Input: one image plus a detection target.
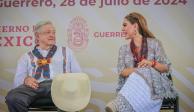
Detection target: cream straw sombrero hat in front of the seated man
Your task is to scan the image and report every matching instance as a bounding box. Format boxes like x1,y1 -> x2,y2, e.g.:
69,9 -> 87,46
51,73 -> 91,111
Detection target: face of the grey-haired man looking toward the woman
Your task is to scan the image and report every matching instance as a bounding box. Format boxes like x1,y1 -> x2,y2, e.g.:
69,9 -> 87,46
36,24 -> 56,46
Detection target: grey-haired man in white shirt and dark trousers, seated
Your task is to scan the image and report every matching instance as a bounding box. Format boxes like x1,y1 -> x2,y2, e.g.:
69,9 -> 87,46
6,21 -> 81,112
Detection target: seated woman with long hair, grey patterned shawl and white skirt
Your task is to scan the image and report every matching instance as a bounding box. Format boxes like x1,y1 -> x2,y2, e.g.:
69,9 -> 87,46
105,12 -> 176,112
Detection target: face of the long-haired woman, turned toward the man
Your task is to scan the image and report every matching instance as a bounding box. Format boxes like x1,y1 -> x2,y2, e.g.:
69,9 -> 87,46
122,19 -> 137,39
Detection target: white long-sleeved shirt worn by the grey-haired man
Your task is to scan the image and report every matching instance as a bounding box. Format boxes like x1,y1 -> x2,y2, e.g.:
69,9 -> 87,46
13,47 -> 81,88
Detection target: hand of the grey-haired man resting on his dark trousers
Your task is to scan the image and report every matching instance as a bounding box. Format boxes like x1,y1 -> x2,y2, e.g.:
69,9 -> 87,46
24,76 -> 39,89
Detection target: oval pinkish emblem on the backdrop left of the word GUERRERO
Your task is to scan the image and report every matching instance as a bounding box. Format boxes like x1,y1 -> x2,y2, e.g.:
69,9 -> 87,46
67,16 -> 89,50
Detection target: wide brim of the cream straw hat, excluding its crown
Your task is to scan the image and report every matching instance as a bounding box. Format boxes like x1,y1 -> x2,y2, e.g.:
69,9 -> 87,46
51,73 -> 91,111
